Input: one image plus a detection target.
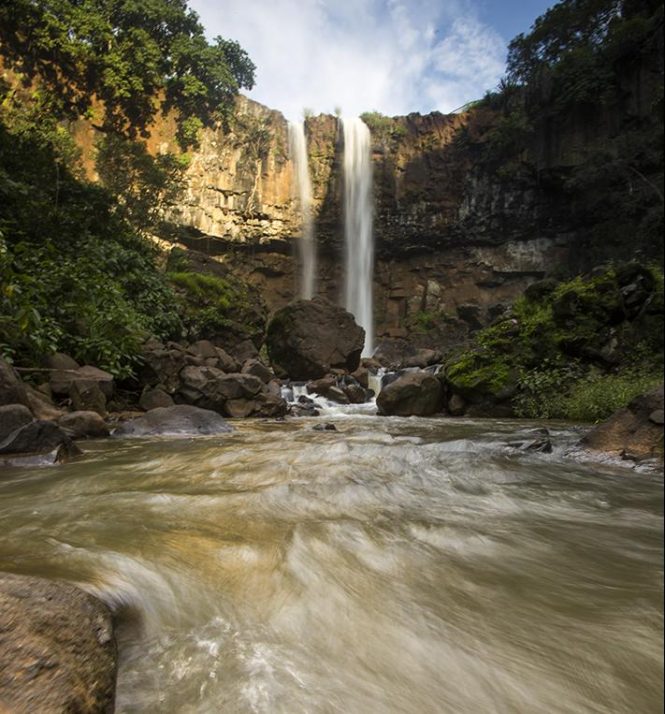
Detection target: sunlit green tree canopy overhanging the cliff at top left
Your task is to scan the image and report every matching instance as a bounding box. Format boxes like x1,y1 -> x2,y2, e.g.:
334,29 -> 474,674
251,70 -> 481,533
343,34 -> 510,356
0,0 -> 255,143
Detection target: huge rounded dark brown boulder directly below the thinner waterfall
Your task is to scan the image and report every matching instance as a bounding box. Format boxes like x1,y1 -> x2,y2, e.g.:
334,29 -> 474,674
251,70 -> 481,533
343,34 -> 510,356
267,297 -> 365,380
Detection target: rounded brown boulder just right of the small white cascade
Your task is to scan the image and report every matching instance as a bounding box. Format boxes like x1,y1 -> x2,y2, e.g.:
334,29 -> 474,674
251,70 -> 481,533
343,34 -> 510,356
376,372 -> 443,416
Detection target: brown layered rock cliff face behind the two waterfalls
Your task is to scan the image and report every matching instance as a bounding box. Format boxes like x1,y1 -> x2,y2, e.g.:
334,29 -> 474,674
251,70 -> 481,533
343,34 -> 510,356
162,99 -> 569,344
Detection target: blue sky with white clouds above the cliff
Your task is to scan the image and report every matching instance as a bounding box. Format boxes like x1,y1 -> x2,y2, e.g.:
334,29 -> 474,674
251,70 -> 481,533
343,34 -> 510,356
189,0 -> 554,121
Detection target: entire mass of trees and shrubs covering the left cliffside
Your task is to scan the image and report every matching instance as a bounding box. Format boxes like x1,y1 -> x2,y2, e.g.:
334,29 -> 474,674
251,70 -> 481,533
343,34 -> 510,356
0,0 -> 254,376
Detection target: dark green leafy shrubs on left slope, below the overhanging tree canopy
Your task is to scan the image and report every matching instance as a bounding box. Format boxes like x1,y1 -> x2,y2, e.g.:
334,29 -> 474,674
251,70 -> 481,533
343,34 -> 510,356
0,80 -> 182,376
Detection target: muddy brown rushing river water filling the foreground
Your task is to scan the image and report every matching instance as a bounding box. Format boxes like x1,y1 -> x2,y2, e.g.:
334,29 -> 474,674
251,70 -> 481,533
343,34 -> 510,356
0,414 -> 663,714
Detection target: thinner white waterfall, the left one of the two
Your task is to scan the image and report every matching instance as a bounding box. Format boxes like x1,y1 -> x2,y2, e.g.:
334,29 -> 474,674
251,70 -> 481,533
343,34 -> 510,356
289,122 -> 316,300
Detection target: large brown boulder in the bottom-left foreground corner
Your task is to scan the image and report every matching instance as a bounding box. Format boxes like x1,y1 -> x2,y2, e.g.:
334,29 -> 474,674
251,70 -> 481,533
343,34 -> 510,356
0,573 -> 117,714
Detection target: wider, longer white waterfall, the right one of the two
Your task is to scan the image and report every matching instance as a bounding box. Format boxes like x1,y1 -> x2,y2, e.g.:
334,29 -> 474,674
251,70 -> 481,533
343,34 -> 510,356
342,117 -> 374,357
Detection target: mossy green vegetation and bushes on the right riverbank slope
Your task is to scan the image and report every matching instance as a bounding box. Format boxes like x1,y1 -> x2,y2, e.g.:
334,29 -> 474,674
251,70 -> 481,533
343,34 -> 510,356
446,263 -> 663,421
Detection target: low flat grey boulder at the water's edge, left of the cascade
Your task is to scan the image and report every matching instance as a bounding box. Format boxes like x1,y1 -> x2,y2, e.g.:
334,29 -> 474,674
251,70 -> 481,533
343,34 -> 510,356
113,404 -> 232,437
